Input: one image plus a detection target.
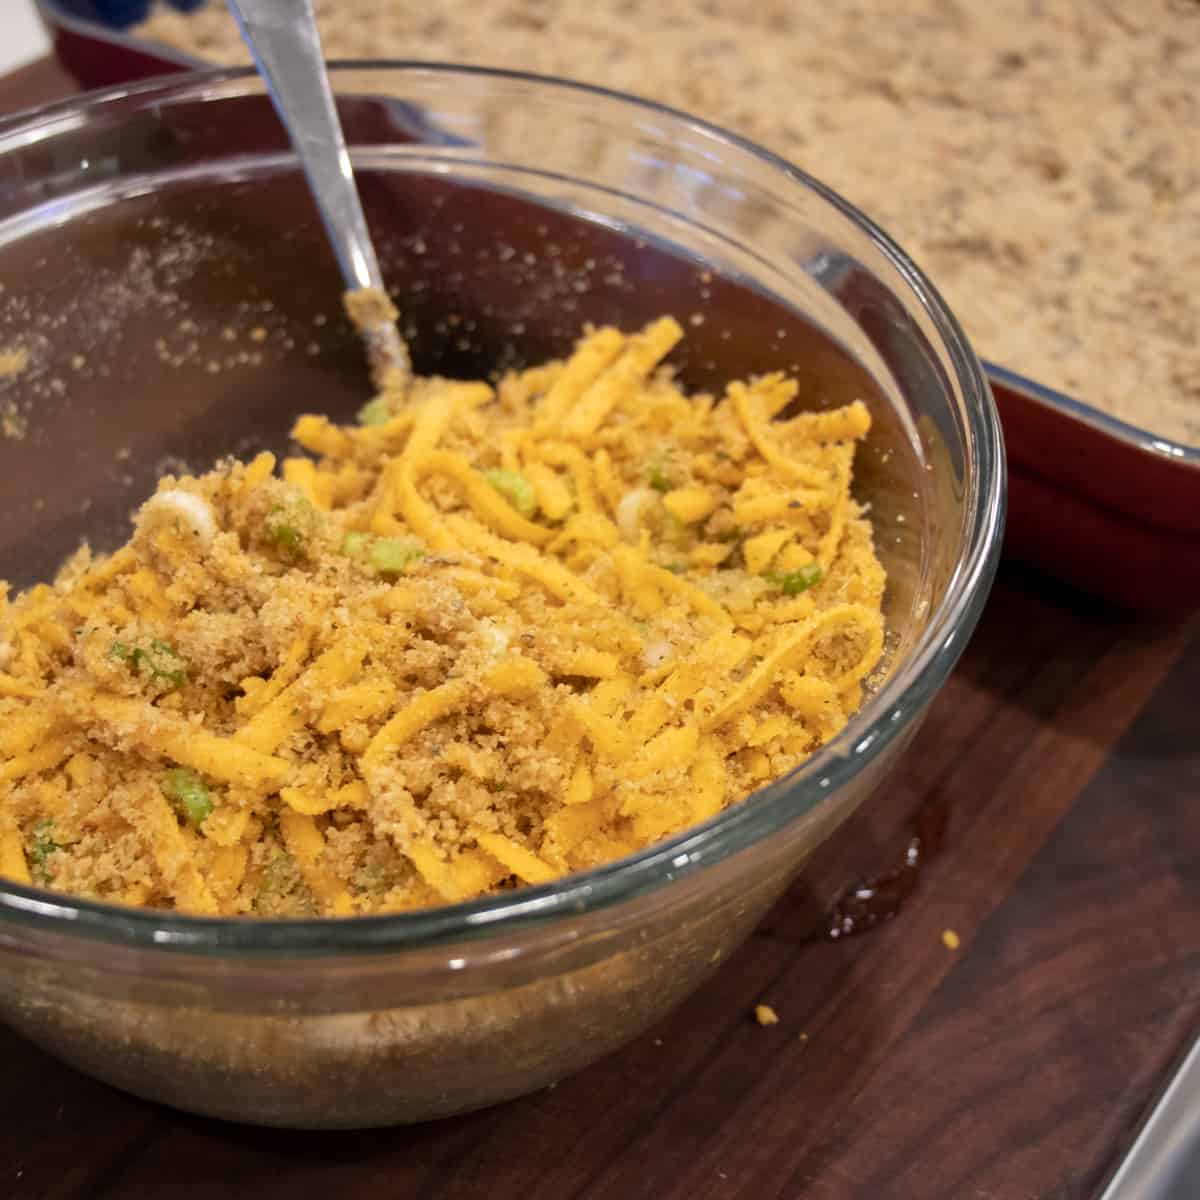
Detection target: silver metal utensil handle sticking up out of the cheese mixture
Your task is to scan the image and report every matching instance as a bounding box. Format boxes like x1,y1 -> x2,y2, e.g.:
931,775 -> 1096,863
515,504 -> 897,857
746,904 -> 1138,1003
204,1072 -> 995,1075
229,0 -> 412,389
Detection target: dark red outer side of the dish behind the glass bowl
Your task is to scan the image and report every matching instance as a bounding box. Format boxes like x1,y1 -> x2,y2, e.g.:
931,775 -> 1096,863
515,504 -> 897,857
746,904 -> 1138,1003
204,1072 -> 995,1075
25,0 -> 1200,611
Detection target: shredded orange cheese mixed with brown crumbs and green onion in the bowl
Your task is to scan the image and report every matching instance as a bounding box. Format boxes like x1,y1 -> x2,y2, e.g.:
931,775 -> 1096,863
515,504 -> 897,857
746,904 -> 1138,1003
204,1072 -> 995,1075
0,318 -> 884,907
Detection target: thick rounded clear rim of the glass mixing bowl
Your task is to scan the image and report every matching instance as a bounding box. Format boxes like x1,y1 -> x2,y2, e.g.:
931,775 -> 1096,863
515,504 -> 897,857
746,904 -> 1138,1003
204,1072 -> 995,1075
0,59 -> 1007,958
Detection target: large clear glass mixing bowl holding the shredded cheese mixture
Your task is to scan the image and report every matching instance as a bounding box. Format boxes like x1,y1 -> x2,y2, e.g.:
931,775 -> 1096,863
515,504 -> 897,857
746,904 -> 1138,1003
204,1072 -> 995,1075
0,64 -> 1004,1128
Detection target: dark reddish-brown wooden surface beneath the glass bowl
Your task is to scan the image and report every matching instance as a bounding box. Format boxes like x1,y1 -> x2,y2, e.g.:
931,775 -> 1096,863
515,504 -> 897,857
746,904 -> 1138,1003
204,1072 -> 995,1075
0,64 -> 1200,1200
